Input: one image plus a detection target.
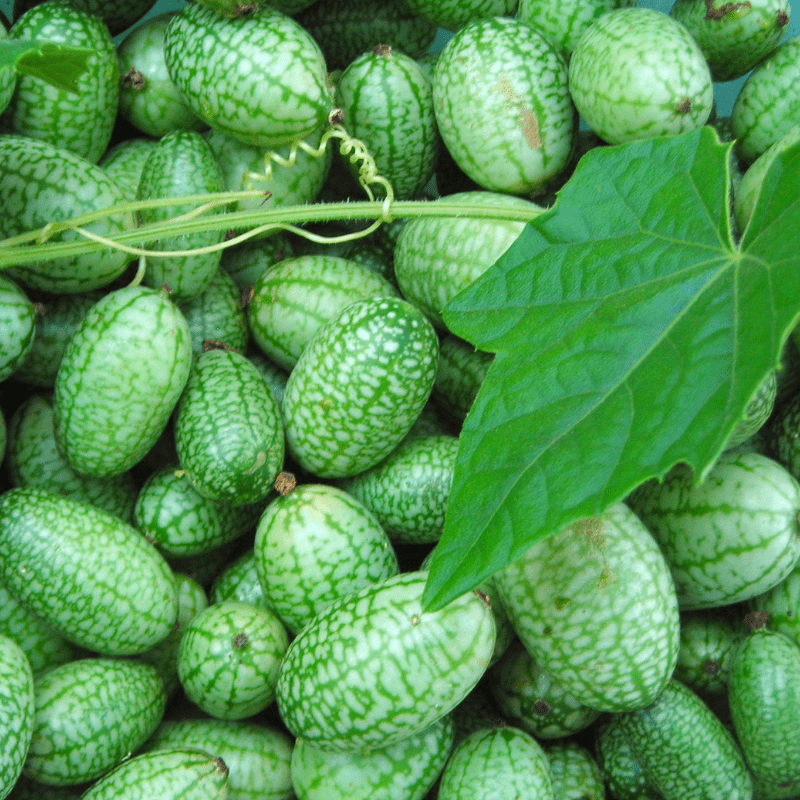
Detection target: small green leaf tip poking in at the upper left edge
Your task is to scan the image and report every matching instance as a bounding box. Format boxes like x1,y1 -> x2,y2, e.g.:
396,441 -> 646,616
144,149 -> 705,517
0,39 -> 94,94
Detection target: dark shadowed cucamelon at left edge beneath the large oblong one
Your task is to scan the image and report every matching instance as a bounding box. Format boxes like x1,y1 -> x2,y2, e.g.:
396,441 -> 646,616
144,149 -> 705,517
0,583 -> 82,675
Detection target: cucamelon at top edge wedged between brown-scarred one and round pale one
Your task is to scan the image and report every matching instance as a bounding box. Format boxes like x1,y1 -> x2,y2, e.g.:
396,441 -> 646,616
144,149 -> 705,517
517,0 -> 636,62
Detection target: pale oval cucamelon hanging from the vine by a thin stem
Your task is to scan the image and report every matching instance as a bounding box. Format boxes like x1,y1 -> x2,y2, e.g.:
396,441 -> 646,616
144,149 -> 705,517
53,286 -> 192,477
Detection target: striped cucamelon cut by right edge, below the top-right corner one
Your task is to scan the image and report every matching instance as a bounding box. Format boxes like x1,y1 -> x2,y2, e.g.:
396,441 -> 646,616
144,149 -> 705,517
731,36 -> 800,162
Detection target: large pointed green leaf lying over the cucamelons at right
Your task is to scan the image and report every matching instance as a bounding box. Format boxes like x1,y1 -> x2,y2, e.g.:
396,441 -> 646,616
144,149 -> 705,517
424,128 -> 800,609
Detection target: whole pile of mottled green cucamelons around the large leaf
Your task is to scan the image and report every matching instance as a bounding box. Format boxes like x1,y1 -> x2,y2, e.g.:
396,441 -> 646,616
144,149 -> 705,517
0,0 -> 800,800
